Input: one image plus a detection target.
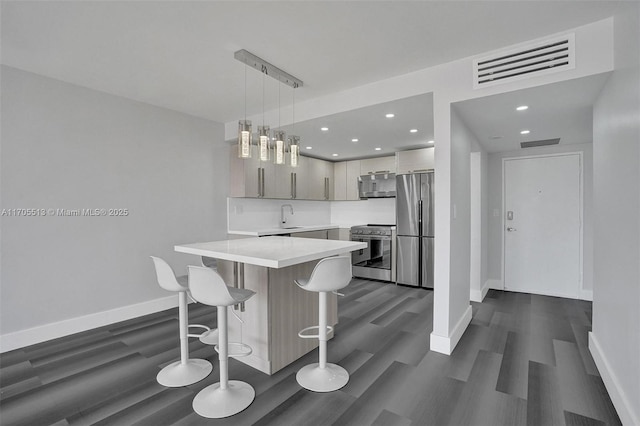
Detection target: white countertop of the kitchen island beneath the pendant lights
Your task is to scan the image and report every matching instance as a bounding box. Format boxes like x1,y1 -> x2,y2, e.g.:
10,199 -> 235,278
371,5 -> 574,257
174,235 -> 367,268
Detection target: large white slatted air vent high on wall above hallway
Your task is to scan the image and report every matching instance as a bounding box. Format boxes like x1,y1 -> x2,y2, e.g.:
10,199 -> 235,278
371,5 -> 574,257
473,34 -> 575,89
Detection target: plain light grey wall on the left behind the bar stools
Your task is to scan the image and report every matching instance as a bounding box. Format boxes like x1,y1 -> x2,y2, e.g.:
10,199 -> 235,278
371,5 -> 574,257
0,67 -> 228,351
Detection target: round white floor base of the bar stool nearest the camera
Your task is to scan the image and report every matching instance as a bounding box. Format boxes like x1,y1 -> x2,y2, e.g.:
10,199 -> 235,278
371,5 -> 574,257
193,380 -> 256,419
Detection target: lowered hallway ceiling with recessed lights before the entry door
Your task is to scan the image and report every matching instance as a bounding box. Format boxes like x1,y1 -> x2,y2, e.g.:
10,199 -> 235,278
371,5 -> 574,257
454,73 -> 609,153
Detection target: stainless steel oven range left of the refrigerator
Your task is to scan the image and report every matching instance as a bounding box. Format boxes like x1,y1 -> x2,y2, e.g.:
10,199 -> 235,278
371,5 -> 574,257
350,224 -> 395,281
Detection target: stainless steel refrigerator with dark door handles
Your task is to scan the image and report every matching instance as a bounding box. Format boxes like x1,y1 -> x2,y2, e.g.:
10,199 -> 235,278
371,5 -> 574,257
396,172 -> 434,288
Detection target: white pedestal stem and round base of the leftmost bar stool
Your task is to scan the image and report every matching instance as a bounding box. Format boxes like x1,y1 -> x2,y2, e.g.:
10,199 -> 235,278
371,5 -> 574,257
156,291 -> 213,388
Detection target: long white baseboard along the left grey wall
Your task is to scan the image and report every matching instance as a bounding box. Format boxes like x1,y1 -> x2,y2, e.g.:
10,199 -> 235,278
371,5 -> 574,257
0,295 -> 178,353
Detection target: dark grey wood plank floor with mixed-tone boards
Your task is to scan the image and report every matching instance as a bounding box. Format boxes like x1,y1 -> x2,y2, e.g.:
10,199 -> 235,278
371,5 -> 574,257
0,280 -> 620,426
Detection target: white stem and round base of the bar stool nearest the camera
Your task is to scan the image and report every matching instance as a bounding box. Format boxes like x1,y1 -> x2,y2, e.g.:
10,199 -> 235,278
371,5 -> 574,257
193,306 -> 256,419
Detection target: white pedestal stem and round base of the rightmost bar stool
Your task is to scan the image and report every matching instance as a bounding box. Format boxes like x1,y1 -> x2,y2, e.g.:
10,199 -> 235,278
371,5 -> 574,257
296,291 -> 349,392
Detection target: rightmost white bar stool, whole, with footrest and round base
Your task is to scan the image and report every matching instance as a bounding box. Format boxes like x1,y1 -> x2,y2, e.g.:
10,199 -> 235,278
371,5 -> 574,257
295,256 -> 352,392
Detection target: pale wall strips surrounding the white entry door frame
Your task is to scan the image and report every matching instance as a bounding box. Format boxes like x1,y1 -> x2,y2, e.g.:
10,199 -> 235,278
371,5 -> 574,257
487,143 -> 593,300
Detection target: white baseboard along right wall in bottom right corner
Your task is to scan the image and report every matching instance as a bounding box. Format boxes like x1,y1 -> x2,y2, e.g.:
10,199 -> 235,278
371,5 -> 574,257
589,332 -> 640,425
